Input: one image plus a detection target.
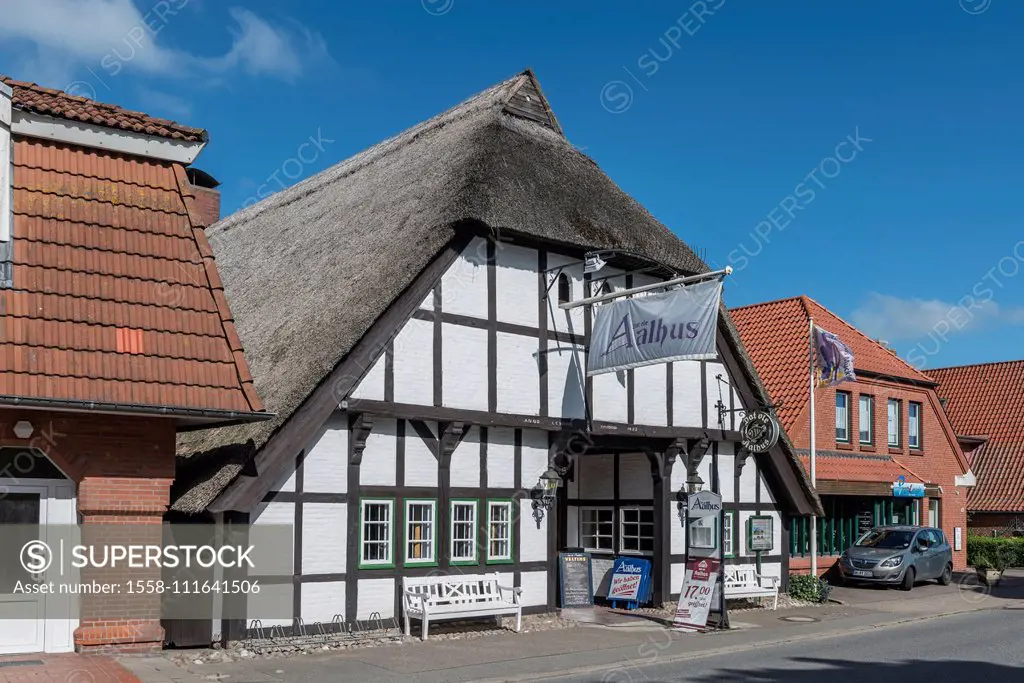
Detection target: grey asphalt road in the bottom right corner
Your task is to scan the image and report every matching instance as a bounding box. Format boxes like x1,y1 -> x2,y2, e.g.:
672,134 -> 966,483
544,609 -> 1024,683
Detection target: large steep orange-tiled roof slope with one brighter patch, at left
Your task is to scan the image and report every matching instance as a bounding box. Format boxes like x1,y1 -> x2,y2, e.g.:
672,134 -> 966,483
0,137 -> 262,413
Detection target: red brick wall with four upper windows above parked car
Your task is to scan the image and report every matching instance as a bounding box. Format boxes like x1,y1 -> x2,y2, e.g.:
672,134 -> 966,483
790,378 -> 968,570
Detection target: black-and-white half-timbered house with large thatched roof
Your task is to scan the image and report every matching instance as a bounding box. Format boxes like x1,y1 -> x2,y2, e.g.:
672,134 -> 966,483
173,72 -> 818,637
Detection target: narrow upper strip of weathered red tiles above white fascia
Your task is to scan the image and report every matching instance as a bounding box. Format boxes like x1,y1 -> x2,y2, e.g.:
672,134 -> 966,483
0,75 -> 207,142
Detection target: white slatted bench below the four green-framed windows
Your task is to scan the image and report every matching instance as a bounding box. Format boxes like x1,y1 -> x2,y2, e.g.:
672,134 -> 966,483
401,572 -> 522,640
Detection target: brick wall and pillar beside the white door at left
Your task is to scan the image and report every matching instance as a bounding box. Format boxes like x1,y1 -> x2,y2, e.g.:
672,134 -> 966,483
0,410 -> 174,650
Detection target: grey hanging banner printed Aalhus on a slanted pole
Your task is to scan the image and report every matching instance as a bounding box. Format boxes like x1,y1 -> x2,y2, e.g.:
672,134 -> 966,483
587,280 -> 722,375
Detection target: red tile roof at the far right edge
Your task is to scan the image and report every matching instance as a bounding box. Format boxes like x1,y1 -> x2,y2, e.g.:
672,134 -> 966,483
928,360 -> 1024,512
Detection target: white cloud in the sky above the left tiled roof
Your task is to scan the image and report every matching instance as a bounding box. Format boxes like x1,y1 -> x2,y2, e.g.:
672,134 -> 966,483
0,0 -> 330,87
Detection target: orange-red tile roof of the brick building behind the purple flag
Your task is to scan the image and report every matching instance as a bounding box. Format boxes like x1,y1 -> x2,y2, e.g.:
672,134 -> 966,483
729,296 -> 933,431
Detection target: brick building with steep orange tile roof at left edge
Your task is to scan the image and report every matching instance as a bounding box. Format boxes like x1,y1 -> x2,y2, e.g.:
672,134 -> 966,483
0,77 -> 268,654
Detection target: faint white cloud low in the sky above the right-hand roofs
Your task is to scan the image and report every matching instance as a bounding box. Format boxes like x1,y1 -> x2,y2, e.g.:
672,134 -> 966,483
850,292 -> 1024,342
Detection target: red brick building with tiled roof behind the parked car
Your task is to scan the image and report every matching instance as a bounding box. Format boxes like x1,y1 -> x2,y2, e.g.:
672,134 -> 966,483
732,296 -> 974,572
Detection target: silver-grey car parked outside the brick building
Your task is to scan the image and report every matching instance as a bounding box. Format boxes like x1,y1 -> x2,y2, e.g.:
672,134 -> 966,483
839,526 -> 953,591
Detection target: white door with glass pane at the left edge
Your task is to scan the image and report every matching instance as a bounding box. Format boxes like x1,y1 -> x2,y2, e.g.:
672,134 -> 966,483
0,484 -> 49,654
